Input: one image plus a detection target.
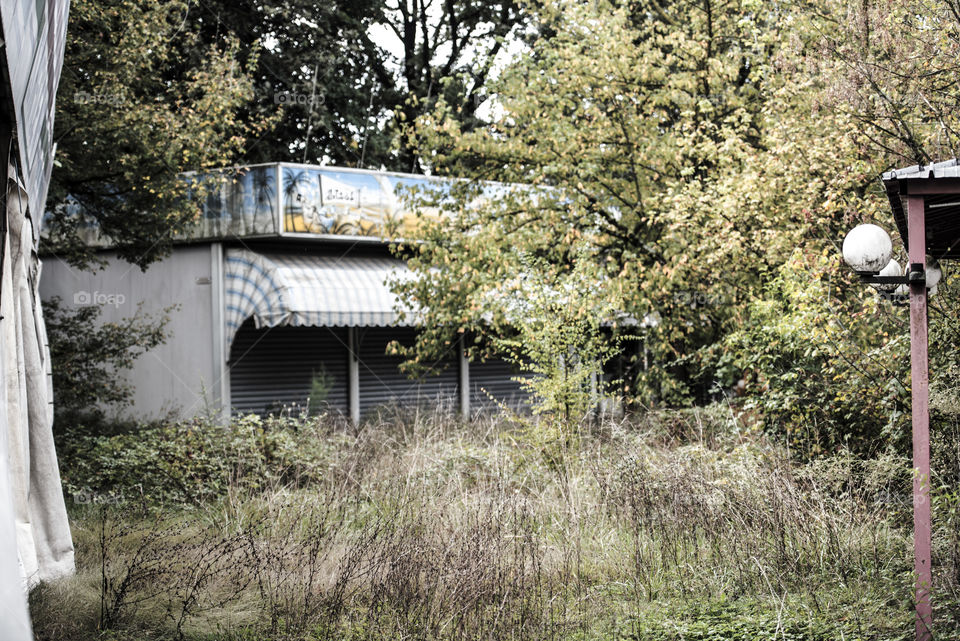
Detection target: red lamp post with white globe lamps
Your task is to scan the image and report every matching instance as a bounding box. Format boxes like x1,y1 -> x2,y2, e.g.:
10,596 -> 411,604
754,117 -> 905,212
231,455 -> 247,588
843,216 -> 941,641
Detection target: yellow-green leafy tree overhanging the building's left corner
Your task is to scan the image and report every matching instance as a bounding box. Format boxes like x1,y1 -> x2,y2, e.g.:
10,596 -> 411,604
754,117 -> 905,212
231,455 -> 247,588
43,0 -> 263,267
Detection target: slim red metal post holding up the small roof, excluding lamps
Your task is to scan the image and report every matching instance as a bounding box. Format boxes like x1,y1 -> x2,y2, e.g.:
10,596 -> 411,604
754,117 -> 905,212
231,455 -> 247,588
907,196 -> 933,641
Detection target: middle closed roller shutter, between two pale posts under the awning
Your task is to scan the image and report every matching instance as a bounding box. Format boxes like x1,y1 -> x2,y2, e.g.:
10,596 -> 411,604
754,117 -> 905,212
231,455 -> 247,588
357,327 -> 457,415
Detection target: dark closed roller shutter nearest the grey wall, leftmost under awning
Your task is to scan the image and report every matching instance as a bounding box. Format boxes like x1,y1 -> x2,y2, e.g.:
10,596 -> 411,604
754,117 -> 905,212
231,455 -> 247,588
230,320 -> 347,414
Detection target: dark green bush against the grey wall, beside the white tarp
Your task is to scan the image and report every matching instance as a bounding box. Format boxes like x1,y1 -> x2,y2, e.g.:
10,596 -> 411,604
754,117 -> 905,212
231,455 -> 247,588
43,297 -> 170,432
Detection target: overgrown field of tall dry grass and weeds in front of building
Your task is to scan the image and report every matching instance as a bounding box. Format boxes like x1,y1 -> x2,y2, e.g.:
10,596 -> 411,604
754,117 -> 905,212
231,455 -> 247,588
31,408 -> 960,641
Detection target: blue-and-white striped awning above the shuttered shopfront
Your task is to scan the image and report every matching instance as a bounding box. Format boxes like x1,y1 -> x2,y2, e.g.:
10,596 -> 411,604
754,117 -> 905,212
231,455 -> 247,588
224,249 -> 411,343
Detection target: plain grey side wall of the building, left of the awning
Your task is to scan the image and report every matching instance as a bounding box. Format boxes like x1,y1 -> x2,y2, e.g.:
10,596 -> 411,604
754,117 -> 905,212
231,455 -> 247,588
40,244 -> 223,418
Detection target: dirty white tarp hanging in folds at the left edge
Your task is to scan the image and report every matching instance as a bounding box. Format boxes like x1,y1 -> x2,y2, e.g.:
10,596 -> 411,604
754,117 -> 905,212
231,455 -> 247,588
0,167 -> 74,640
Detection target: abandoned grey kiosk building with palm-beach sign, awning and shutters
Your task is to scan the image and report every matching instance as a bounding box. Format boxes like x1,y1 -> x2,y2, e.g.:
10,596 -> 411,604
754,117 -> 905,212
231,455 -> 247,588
40,163 -> 526,421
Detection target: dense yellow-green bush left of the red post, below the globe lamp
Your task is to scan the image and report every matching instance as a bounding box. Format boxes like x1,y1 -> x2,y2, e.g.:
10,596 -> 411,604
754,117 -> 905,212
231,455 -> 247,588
707,250 -> 910,456
